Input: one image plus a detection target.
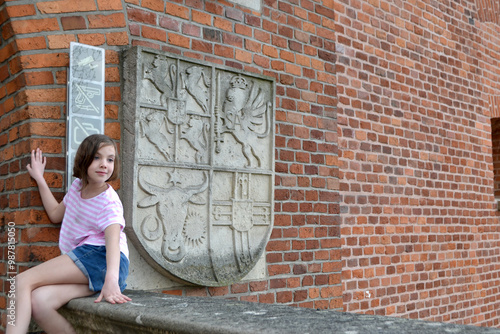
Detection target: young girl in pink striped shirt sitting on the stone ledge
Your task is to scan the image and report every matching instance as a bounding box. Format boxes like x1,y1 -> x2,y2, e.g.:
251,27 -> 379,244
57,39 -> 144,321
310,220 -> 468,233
7,135 -> 130,334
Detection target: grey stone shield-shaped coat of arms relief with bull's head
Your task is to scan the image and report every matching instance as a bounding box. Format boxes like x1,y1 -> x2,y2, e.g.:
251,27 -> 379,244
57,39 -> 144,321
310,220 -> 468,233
121,47 -> 276,286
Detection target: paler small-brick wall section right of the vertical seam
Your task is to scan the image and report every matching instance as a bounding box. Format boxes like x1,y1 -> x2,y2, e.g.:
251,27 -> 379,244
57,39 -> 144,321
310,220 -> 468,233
335,0 -> 500,327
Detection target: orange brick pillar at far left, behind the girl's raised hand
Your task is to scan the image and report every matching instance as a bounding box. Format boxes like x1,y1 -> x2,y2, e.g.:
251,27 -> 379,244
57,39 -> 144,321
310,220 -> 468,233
0,1 -> 128,328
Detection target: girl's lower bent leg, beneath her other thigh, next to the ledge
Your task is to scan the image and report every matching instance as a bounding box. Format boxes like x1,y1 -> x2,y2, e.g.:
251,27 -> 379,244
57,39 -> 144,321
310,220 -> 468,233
31,284 -> 95,334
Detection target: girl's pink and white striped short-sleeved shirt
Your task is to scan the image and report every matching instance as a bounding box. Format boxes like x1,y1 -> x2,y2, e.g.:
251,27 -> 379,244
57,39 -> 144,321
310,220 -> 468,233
59,179 -> 128,258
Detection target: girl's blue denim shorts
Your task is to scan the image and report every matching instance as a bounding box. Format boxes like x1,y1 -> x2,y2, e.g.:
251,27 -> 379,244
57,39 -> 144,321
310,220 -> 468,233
67,245 -> 129,292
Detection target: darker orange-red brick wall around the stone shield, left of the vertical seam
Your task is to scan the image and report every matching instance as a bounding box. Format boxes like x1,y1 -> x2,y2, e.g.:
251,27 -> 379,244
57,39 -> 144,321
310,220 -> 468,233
0,0 -> 342,332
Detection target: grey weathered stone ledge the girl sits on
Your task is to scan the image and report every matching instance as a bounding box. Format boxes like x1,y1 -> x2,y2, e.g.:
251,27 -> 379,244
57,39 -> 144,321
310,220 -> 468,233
60,291 -> 500,334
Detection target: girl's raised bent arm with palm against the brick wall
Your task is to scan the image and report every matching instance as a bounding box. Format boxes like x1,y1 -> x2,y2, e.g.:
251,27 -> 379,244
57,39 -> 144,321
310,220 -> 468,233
26,148 -> 66,223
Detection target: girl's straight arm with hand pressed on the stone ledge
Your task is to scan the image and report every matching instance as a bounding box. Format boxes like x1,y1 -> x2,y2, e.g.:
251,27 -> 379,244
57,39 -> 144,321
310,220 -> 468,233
95,224 -> 131,304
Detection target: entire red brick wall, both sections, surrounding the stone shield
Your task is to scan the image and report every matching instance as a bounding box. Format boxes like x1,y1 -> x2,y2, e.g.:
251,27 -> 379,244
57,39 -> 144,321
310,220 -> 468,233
0,0 -> 500,327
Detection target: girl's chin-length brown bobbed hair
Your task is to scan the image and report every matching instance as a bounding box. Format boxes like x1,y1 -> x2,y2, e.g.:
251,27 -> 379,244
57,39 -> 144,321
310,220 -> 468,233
73,134 -> 120,189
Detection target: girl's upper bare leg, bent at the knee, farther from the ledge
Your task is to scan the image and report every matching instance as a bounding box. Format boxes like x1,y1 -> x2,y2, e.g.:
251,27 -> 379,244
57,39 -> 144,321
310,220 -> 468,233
7,255 -> 88,334
